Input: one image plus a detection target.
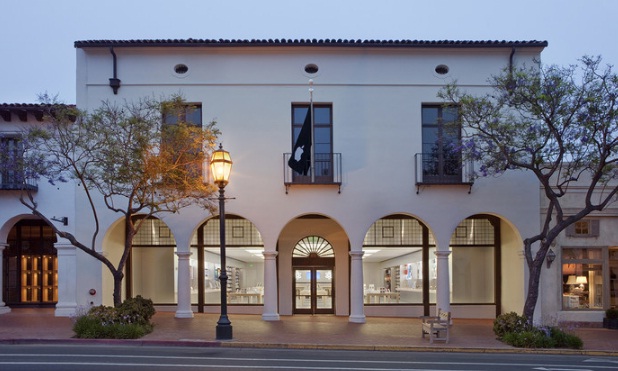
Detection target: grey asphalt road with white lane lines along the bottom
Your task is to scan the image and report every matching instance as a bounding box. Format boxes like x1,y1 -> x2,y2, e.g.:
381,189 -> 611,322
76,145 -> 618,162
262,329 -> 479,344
0,344 -> 618,371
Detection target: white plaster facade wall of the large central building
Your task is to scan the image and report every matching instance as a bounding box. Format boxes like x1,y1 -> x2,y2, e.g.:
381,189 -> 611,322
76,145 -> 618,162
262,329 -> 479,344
72,42 -> 540,313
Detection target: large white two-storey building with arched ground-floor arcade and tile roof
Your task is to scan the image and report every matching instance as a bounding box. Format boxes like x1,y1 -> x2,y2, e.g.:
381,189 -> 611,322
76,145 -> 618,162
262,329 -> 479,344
0,39 -> 558,322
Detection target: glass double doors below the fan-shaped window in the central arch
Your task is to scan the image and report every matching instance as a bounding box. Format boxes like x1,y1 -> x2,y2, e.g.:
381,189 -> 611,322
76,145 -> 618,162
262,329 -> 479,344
294,267 -> 335,314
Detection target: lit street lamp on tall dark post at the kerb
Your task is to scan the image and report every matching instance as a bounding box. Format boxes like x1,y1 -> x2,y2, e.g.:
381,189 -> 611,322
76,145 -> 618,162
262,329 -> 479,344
210,144 -> 232,340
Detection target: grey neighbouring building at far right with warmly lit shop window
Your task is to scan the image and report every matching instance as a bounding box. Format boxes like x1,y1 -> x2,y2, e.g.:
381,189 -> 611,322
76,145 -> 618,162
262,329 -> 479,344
539,174 -> 618,324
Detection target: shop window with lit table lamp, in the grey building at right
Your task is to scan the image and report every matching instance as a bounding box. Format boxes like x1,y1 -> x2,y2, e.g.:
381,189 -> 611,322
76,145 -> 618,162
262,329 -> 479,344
562,247 -> 604,310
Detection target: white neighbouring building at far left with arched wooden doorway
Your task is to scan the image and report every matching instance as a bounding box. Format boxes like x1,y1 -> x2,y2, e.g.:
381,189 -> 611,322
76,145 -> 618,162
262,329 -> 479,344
0,104 -> 76,315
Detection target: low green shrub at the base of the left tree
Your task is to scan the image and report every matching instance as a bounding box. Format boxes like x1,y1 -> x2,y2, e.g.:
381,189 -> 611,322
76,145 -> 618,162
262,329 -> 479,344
73,296 -> 155,339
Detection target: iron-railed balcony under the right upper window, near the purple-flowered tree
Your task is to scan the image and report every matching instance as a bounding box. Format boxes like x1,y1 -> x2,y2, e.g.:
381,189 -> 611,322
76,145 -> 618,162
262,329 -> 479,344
414,153 -> 474,194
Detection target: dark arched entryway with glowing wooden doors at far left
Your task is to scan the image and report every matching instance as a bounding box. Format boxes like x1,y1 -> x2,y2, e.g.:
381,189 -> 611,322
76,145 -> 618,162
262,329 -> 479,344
2,220 -> 58,307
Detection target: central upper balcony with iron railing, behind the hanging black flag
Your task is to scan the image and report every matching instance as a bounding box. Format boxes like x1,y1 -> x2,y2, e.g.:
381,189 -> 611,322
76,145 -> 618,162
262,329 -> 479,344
283,153 -> 341,194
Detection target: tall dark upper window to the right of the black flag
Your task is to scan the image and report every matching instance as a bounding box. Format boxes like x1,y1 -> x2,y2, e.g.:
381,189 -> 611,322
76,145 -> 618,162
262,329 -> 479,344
422,105 -> 462,184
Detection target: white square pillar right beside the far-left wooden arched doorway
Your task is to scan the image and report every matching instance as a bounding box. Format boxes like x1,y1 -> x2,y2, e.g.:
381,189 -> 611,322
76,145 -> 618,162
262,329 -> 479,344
54,243 -> 77,317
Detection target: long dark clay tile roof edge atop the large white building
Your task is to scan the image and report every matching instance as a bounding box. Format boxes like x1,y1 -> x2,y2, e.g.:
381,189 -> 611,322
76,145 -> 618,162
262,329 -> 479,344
75,39 -> 548,48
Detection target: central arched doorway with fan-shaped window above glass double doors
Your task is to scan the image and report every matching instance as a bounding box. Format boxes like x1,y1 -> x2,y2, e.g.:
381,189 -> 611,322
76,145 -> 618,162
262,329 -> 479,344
292,236 -> 335,314
